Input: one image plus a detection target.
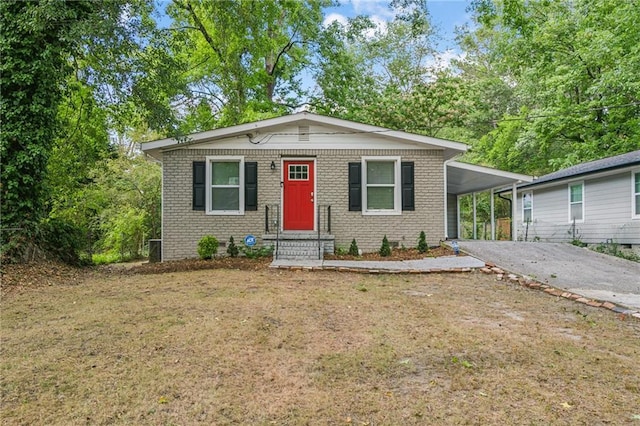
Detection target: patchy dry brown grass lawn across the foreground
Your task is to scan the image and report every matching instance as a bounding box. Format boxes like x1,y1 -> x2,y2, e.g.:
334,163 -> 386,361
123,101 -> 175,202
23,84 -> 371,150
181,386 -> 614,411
0,269 -> 640,425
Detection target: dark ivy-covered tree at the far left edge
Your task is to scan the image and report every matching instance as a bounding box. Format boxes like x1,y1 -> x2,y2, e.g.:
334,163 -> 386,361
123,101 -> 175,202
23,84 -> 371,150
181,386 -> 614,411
0,1 -> 93,257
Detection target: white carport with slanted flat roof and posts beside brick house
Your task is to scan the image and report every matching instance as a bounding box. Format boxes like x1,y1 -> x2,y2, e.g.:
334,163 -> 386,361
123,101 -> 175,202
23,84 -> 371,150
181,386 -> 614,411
444,160 -> 533,241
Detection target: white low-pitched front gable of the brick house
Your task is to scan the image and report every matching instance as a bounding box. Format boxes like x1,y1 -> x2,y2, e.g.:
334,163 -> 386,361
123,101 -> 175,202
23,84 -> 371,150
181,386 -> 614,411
141,112 -> 468,159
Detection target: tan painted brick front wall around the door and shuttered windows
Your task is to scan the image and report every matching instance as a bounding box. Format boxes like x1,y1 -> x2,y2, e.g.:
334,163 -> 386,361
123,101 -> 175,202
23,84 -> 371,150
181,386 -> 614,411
162,149 -> 444,260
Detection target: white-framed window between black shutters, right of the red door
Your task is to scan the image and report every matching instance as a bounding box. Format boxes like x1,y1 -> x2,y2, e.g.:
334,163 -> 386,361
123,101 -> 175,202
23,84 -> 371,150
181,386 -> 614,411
362,157 -> 402,215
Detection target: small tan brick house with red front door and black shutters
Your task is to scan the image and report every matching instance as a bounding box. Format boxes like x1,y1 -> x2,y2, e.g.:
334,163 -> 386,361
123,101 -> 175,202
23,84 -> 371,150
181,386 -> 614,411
142,112 -> 522,260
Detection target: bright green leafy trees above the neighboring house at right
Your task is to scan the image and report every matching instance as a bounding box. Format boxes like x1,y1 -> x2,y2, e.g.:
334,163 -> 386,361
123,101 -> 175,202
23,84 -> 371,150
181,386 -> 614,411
462,0 -> 640,174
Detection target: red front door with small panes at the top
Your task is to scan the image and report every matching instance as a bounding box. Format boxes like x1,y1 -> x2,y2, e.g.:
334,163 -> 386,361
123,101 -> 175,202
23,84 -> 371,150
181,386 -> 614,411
282,160 -> 316,231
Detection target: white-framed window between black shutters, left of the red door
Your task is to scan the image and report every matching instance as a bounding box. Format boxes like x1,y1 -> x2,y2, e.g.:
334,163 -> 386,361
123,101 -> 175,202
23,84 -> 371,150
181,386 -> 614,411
206,156 -> 244,215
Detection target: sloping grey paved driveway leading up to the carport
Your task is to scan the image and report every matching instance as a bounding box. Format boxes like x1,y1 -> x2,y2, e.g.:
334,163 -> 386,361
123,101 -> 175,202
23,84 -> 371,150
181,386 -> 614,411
459,241 -> 640,310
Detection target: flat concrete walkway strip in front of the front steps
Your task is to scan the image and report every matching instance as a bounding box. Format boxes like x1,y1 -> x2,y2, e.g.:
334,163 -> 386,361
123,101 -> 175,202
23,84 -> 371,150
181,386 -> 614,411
271,256 -> 484,272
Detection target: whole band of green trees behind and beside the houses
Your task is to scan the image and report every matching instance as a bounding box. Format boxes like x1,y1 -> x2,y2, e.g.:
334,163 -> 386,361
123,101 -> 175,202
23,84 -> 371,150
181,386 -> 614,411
0,0 -> 640,259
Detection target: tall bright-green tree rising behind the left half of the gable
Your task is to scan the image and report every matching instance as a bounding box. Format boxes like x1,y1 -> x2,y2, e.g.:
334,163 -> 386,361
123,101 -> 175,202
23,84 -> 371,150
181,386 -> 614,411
167,0 -> 331,130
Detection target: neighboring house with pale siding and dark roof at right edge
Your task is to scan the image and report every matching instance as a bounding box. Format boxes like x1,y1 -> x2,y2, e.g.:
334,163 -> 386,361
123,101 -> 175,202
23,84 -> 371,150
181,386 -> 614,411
517,150 -> 640,250
